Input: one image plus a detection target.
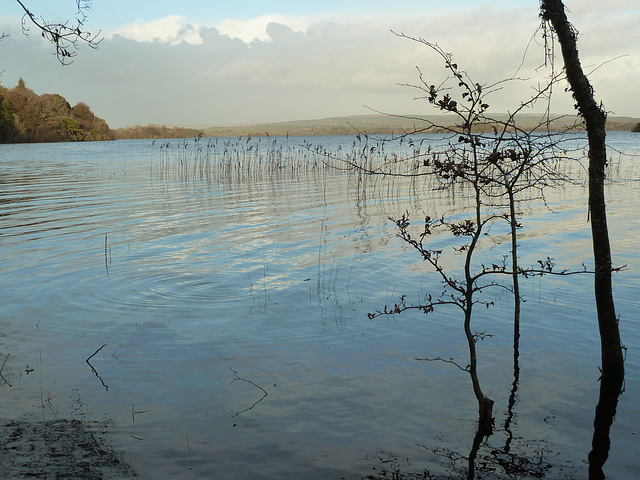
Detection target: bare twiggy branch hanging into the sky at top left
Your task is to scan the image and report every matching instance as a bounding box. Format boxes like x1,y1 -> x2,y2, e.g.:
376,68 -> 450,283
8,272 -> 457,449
16,0 -> 101,65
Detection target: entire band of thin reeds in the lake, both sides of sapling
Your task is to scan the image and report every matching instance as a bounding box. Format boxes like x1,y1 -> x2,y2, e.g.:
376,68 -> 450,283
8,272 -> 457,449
153,132 -> 620,216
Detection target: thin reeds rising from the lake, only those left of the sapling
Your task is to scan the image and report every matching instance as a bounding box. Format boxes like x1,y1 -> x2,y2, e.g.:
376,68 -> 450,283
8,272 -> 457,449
152,134 -> 470,215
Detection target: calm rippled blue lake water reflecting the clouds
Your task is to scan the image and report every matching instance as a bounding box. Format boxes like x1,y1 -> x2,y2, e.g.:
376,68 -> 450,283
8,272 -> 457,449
0,132 -> 640,480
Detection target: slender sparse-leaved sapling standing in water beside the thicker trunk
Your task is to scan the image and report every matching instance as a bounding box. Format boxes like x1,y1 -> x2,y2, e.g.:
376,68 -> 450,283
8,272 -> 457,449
310,27 -> 608,478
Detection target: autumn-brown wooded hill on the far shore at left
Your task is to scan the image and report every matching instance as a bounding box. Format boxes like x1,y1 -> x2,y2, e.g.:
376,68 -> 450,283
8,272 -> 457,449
0,78 -> 115,143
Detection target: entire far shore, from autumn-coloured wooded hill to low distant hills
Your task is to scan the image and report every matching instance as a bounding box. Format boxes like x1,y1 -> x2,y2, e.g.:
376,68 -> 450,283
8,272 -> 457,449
0,78 -> 640,143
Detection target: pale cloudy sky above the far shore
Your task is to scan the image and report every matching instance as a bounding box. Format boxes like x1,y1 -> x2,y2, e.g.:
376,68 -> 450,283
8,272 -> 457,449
0,0 -> 640,128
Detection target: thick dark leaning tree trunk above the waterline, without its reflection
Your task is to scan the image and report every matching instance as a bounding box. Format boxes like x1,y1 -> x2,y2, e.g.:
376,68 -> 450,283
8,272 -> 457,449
541,0 -> 624,377
